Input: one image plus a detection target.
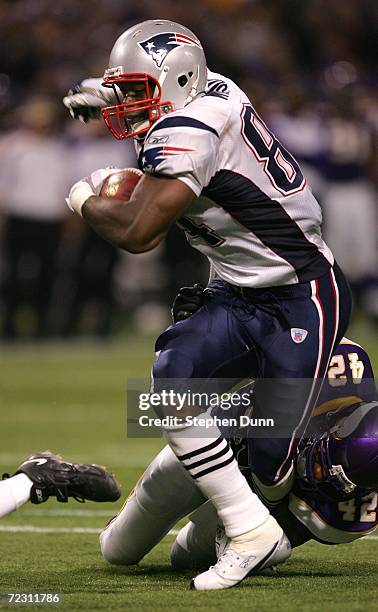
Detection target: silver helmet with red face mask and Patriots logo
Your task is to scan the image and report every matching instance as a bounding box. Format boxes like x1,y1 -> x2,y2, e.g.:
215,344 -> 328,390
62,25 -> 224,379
101,19 -> 207,140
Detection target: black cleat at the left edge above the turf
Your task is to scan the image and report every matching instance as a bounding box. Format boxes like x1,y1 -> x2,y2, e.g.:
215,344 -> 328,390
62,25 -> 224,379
2,451 -> 121,504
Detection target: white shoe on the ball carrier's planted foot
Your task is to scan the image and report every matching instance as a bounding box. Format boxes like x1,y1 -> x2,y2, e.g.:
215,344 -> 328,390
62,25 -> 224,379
190,516 -> 291,591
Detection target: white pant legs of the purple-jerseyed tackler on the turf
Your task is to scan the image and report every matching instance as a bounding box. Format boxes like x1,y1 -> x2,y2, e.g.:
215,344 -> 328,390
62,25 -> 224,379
100,446 -> 218,568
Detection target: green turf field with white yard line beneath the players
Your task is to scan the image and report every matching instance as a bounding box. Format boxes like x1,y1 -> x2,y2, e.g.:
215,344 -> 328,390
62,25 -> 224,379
0,328 -> 378,612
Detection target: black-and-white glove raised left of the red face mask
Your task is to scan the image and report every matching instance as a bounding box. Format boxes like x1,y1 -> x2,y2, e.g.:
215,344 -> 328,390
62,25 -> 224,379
63,78 -> 117,123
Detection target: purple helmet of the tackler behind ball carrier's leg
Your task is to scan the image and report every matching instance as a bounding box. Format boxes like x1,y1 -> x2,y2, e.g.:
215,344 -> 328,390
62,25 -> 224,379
296,402 -> 378,498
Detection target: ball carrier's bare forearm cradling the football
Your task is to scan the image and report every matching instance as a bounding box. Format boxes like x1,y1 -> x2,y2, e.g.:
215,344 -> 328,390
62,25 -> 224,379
82,196 -> 165,253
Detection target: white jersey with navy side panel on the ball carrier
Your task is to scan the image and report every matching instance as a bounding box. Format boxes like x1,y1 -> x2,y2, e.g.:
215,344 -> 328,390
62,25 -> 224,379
139,72 -> 333,287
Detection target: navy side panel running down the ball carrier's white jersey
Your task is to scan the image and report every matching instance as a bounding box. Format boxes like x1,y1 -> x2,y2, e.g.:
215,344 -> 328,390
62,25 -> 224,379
202,170 -> 330,282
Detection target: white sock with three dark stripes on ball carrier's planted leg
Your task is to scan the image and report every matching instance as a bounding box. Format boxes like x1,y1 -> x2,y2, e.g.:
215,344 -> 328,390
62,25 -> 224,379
165,424 -> 269,538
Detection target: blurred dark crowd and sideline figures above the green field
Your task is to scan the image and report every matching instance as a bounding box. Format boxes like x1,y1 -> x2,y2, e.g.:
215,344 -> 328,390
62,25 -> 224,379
0,0 -> 378,340
